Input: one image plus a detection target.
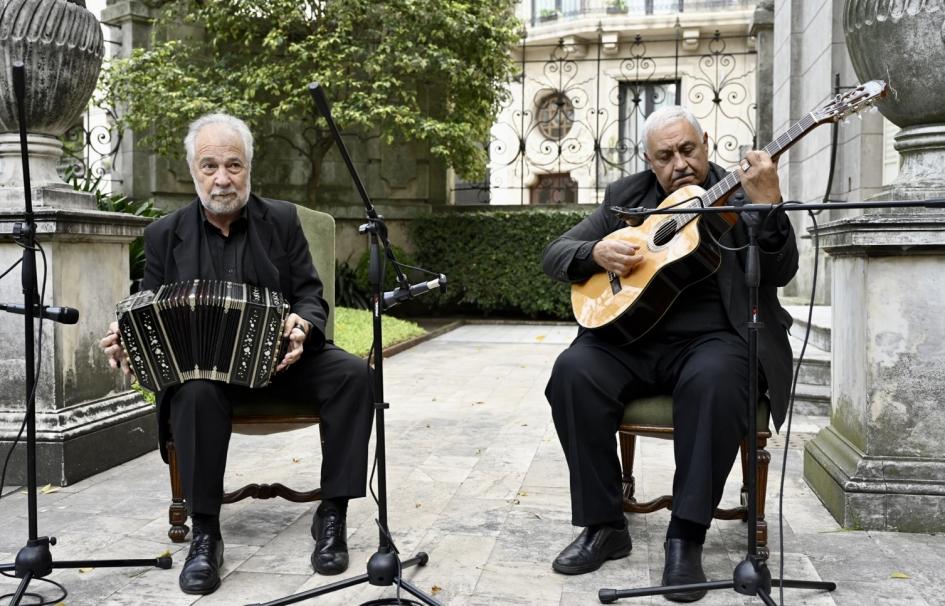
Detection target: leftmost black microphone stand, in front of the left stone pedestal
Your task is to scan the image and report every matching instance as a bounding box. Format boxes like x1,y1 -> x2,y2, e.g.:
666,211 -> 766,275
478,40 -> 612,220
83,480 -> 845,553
0,61 -> 171,606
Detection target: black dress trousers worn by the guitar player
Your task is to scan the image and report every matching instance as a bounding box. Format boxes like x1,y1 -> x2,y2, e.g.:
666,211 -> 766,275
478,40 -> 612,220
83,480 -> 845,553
545,331 -> 752,526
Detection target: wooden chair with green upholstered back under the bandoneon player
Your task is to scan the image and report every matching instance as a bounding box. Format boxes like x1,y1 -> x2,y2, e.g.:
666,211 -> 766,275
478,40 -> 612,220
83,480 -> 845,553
166,206 -> 335,543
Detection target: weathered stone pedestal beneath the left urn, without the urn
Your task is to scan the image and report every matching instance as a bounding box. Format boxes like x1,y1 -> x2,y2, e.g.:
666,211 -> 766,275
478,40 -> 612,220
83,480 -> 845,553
0,204 -> 157,485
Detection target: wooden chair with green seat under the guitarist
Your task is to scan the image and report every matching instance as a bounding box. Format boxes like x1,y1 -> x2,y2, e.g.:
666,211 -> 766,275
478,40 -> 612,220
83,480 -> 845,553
619,396 -> 771,559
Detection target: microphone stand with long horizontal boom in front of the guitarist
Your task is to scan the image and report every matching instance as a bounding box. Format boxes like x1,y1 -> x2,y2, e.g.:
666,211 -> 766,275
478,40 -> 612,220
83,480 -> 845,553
597,199 -> 945,606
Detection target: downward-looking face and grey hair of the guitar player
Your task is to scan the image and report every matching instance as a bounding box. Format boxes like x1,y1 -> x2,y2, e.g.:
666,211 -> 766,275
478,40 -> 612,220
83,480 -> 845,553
644,119 -> 709,194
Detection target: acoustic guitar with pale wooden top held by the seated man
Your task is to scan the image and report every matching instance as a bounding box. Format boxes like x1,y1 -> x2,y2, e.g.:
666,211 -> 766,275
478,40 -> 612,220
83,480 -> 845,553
571,80 -> 887,343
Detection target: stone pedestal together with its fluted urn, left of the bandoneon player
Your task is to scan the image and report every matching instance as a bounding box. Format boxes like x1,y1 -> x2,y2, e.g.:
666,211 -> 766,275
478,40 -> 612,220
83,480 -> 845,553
0,0 -> 157,485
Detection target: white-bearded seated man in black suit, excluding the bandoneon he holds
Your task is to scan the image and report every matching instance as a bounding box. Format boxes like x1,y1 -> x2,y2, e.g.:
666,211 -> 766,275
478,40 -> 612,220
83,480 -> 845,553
101,114 -> 373,594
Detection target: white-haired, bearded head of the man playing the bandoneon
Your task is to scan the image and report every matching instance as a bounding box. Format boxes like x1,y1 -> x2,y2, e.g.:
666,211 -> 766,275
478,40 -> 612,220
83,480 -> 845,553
190,124 -> 250,215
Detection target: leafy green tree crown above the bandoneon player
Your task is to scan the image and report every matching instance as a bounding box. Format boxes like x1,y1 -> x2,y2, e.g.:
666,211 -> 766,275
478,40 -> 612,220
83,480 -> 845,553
103,0 -> 521,200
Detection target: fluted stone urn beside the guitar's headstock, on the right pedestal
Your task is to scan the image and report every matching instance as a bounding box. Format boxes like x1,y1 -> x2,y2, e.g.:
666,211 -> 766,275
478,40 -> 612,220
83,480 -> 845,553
843,0 -> 945,198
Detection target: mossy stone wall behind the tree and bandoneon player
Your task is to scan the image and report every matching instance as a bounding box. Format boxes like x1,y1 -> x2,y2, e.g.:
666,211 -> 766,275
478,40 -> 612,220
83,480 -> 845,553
102,0 -> 448,263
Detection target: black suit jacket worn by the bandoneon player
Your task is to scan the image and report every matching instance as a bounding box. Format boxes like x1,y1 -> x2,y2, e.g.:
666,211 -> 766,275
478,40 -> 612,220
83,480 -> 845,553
141,194 -> 328,461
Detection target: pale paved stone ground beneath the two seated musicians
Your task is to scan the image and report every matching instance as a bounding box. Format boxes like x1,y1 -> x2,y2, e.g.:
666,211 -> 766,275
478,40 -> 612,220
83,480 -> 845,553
0,325 -> 945,606
